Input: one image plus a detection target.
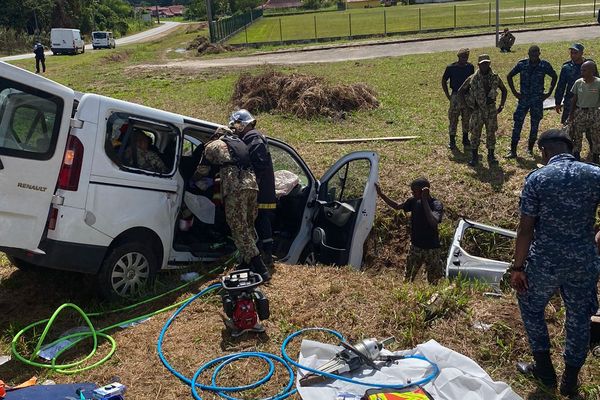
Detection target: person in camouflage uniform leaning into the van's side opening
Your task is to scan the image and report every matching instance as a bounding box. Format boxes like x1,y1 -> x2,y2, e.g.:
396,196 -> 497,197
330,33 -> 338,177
203,128 -> 271,282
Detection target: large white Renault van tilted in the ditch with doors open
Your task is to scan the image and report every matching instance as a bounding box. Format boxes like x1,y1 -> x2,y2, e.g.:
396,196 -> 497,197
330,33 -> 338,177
0,62 -> 379,297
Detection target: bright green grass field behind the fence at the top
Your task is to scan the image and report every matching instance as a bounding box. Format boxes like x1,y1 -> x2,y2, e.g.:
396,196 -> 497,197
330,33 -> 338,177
229,0 -> 597,43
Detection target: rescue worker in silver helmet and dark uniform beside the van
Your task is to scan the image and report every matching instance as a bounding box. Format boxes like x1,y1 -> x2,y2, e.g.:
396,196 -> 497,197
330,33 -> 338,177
229,109 -> 277,268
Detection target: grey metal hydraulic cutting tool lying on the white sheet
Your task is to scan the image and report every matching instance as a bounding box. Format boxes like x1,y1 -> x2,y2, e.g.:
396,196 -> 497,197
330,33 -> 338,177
300,337 -> 404,386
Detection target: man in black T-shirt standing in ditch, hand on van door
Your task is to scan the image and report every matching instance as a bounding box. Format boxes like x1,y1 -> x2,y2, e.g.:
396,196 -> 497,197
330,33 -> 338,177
375,178 -> 444,283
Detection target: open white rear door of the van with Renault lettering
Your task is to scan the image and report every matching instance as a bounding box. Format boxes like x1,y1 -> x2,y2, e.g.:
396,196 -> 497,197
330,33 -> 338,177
0,62 -> 75,251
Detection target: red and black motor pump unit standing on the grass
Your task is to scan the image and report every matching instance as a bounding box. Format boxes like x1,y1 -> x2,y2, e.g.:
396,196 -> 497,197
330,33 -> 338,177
221,269 -> 269,337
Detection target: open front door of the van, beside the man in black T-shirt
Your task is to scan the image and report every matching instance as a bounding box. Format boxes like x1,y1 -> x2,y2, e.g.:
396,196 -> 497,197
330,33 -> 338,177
312,151 -> 379,269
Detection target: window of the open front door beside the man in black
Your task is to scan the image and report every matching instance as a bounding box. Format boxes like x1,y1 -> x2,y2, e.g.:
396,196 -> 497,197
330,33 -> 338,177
321,159 -> 371,203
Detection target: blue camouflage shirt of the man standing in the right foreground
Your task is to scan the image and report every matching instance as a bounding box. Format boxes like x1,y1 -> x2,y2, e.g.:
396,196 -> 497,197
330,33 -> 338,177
520,154 -> 600,274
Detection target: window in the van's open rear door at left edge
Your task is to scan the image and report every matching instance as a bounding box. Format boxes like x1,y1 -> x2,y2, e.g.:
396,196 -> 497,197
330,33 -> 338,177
0,78 -> 64,160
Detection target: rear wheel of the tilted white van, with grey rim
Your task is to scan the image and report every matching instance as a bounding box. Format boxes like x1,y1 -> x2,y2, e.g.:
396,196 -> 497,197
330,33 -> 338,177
98,242 -> 158,299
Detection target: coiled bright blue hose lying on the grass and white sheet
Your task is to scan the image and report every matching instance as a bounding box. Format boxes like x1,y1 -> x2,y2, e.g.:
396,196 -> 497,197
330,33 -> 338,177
157,283 -> 440,400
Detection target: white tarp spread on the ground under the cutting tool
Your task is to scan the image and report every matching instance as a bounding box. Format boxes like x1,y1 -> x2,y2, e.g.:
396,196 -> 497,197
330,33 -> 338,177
296,340 -> 522,400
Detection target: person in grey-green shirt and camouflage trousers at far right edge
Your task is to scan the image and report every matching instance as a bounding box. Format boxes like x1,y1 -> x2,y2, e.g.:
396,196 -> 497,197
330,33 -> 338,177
569,61 -> 600,163
